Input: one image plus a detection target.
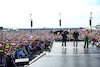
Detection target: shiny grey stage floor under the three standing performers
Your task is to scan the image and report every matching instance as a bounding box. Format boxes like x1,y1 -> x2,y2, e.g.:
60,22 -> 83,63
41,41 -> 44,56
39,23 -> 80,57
29,42 -> 100,67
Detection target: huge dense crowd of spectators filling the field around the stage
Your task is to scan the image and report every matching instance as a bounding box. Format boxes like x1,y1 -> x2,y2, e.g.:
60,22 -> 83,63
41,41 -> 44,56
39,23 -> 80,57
0,29 -> 100,66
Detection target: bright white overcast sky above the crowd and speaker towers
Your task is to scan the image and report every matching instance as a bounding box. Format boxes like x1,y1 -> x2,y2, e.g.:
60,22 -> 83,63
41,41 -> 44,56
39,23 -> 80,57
0,0 -> 100,28
